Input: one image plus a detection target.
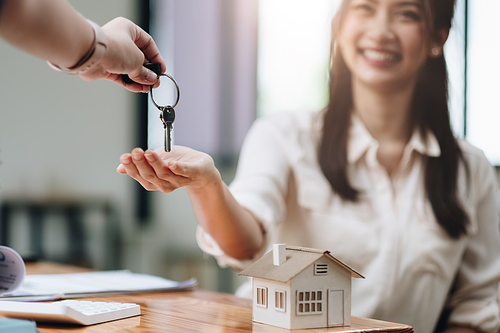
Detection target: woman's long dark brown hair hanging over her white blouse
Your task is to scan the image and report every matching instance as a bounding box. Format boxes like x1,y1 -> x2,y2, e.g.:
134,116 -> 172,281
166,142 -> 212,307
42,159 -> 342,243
318,0 -> 469,239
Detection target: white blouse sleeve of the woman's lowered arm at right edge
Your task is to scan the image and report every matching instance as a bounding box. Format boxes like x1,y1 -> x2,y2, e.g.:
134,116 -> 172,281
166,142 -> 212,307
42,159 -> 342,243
449,151 -> 500,333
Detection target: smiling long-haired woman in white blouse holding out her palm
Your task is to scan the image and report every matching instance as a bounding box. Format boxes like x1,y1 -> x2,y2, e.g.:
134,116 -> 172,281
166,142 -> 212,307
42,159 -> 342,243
118,0 -> 500,333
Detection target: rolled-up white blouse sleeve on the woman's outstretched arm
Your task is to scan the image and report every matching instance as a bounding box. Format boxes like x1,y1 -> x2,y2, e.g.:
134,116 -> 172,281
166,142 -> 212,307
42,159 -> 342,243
196,117 -> 293,270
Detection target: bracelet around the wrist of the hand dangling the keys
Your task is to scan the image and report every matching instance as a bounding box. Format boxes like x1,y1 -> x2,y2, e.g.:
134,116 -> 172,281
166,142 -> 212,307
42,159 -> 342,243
47,20 -> 108,75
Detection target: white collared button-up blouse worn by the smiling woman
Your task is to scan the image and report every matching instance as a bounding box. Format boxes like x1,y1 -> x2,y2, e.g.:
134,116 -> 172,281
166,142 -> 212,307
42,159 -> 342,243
197,112 -> 500,333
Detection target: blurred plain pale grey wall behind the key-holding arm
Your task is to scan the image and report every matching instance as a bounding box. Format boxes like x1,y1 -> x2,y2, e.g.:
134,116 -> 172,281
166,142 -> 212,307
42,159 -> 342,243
0,0 -> 133,200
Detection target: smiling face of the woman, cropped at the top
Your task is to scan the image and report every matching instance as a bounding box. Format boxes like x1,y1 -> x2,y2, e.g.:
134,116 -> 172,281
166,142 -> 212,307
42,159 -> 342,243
338,0 -> 431,88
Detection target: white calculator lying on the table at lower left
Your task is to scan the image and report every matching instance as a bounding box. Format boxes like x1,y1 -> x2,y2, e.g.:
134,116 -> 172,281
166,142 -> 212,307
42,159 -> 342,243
0,300 -> 141,325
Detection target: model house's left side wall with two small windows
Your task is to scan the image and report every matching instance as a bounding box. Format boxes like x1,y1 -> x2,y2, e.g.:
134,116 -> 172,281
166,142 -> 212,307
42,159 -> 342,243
252,278 -> 294,329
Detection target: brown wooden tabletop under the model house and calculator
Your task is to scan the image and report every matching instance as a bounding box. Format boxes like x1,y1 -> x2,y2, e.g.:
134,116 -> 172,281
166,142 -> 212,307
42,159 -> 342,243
23,262 -> 413,333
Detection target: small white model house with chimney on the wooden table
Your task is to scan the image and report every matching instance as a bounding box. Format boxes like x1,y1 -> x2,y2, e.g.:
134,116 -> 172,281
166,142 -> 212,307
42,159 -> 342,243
239,244 -> 364,329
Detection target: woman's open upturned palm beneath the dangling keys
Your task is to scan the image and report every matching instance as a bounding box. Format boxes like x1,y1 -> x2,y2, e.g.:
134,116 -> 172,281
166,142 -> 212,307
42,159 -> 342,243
116,146 -> 221,193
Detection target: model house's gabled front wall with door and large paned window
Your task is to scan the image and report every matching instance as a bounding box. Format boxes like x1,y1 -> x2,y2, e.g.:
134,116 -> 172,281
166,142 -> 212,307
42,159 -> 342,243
290,257 -> 351,329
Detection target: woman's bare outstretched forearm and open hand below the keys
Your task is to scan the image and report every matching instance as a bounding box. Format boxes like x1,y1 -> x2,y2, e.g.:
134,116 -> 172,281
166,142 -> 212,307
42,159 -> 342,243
117,146 -> 263,259
